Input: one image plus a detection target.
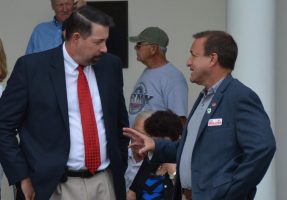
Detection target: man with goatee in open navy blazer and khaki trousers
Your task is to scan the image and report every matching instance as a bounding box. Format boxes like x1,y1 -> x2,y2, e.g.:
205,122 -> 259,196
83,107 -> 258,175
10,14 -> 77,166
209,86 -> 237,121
0,6 -> 129,200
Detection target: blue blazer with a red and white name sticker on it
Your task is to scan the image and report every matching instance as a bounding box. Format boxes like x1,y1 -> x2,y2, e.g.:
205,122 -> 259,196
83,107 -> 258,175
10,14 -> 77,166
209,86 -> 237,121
152,75 -> 276,200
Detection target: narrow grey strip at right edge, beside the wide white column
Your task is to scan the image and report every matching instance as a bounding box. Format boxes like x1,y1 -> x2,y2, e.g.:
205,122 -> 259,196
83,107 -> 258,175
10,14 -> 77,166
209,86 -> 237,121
275,0 -> 287,200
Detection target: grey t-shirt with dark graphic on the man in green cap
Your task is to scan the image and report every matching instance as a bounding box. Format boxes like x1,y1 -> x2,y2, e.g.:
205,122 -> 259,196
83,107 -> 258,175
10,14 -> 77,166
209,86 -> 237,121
129,63 -> 188,126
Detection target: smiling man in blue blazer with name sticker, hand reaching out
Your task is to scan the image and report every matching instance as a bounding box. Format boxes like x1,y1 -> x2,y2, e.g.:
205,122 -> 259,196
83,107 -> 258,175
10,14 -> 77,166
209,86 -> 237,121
124,31 -> 276,200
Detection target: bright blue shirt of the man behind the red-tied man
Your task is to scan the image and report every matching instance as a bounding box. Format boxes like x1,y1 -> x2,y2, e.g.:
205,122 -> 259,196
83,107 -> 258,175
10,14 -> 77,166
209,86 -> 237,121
26,17 -> 63,55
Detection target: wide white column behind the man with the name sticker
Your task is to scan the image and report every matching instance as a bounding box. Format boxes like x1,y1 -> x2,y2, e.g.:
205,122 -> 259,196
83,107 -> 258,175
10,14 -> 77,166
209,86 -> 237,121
226,0 -> 277,200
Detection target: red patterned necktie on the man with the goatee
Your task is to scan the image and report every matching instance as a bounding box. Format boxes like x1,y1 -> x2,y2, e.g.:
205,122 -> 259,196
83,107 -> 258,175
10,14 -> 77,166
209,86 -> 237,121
78,65 -> 101,174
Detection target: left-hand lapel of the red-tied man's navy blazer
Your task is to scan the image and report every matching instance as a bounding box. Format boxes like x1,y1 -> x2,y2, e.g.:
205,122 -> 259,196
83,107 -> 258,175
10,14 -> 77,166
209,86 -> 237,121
50,45 -> 69,130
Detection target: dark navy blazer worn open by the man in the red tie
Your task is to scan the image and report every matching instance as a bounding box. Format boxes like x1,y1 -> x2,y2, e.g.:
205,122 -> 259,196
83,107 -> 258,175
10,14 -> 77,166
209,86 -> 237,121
0,45 -> 129,200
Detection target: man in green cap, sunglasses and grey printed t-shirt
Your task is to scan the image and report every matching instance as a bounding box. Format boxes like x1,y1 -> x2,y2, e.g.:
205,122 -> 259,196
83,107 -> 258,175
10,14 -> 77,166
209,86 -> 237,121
129,27 -> 188,124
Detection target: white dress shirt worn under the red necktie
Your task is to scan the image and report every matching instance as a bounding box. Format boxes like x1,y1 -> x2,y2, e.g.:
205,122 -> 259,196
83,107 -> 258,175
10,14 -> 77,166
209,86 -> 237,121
63,43 -> 110,170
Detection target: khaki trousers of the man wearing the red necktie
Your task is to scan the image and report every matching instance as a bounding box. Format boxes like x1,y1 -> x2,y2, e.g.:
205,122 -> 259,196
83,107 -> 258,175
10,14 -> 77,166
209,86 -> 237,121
50,170 -> 116,200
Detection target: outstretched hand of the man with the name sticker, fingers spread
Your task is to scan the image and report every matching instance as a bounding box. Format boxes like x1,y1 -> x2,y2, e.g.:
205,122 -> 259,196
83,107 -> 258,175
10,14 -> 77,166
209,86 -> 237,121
123,128 -> 155,156
